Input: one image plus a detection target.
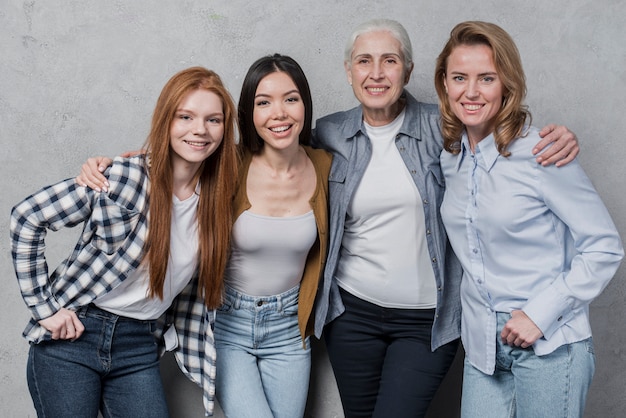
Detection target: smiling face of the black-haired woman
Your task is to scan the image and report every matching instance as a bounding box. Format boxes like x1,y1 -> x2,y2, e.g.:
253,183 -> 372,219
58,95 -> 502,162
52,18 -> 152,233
253,71 -> 305,150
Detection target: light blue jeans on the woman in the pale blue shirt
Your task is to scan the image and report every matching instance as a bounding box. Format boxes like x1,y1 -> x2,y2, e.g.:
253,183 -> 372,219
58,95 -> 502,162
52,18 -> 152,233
461,312 -> 595,418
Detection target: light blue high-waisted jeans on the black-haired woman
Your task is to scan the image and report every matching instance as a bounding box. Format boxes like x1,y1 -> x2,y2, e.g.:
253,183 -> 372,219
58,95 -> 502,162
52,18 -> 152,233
214,286 -> 311,418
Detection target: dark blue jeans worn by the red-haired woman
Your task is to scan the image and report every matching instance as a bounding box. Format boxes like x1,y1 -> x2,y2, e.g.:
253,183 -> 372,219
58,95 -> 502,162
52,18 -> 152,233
27,305 -> 169,418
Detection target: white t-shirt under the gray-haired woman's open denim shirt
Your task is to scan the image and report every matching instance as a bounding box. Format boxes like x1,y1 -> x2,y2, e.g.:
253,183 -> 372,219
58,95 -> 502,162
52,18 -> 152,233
336,111 -> 437,309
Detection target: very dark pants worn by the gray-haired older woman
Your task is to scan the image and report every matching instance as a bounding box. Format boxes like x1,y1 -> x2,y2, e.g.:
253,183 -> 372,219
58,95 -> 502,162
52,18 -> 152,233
325,290 -> 458,418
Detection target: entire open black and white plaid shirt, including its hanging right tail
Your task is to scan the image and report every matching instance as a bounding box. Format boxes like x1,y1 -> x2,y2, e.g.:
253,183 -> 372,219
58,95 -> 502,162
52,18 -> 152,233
10,156 -> 215,415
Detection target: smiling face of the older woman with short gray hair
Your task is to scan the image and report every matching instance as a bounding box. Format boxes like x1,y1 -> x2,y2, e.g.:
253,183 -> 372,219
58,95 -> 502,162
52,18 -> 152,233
345,31 -> 412,126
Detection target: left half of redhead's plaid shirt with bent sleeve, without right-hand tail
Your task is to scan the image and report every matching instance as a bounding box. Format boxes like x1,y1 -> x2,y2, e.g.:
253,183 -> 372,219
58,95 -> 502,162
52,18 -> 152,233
10,157 -> 149,326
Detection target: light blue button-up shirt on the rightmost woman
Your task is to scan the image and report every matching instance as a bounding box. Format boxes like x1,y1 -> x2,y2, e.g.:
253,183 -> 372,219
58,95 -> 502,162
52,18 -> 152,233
441,128 -> 624,374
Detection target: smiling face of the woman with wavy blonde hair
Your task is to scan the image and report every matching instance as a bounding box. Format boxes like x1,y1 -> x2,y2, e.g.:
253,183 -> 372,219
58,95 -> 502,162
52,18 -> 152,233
444,44 -> 505,144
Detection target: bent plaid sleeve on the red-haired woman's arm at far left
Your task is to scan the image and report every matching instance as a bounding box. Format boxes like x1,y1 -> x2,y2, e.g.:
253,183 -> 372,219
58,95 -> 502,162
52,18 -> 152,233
10,179 -> 92,320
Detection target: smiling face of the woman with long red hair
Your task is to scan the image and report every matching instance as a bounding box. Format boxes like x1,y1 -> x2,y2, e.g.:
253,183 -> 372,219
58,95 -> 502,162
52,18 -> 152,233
170,89 -> 224,169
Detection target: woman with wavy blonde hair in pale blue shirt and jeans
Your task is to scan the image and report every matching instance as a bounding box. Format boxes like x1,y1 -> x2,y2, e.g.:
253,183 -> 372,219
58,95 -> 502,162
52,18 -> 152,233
435,22 -> 624,418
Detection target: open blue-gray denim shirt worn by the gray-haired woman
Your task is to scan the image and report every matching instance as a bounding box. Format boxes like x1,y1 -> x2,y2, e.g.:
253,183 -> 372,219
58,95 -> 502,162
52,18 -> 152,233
314,91 -> 462,350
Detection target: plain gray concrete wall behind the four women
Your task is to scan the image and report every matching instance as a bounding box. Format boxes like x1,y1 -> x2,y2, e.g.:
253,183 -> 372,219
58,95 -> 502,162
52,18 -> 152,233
0,0 -> 626,417
